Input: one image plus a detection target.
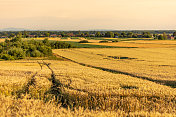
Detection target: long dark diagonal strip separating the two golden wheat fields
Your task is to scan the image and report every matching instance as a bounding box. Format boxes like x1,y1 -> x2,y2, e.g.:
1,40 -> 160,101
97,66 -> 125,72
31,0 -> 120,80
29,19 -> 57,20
54,54 -> 176,88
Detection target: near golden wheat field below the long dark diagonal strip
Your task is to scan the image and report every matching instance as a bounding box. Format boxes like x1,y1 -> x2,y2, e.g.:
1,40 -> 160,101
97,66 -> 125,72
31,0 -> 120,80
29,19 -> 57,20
0,60 -> 176,116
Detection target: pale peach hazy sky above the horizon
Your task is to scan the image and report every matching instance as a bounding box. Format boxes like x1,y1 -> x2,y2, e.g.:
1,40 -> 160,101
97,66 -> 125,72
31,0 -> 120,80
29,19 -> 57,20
0,0 -> 176,30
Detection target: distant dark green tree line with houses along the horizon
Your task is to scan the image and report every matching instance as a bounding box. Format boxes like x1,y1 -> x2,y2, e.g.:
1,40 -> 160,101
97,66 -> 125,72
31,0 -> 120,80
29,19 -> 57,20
0,31 -> 176,39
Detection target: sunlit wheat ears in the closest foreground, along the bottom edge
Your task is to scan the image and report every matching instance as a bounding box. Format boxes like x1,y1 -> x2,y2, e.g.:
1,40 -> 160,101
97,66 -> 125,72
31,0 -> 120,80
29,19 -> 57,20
0,96 -> 176,117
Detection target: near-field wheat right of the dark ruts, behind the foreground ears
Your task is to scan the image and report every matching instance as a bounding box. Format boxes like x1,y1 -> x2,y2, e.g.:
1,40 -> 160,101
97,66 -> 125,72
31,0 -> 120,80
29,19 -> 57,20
44,61 -> 176,113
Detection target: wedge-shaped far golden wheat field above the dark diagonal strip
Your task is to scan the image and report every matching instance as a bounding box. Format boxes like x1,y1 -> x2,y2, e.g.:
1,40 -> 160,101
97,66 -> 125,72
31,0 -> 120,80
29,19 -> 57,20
54,48 -> 176,83
